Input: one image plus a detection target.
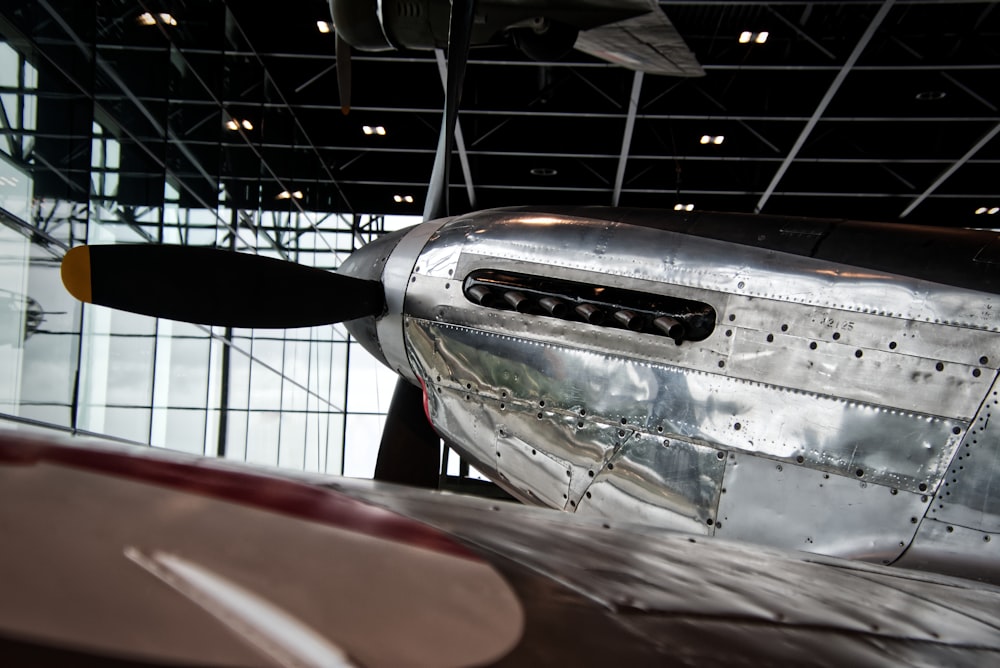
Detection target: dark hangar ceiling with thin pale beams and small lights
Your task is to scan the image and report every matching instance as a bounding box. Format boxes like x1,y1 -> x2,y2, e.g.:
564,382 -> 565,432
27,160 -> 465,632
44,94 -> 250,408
0,0 -> 1000,227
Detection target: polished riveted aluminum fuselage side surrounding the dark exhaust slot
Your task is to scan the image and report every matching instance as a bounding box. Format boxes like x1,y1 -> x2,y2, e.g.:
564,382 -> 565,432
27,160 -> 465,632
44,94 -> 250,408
352,210 -> 1000,581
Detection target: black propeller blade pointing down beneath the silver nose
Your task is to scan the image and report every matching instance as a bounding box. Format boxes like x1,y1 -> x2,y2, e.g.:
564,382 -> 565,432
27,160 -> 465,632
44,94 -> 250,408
375,378 -> 441,489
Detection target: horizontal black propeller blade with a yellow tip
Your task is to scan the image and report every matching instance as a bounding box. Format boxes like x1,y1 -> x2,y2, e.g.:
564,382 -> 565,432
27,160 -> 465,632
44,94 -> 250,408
62,244 -> 385,328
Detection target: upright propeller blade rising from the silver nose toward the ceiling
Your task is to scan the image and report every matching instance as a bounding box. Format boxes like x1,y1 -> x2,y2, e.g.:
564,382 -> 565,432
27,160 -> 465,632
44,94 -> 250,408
424,0 -> 476,220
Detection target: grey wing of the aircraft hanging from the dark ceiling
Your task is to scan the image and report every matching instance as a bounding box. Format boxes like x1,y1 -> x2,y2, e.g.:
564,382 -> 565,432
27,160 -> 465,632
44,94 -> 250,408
574,3 -> 705,77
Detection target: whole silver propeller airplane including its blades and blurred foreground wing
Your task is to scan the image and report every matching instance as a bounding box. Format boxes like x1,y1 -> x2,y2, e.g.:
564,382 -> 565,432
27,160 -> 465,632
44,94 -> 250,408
7,2 -> 1000,667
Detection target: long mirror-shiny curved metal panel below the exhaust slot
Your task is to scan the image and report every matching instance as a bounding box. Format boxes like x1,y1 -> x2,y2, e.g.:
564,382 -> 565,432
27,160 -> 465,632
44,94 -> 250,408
409,321 -> 960,491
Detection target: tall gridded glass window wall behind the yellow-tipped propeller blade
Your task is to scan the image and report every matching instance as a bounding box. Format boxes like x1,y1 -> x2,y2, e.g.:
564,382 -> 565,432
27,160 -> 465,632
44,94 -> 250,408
0,9 -> 415,476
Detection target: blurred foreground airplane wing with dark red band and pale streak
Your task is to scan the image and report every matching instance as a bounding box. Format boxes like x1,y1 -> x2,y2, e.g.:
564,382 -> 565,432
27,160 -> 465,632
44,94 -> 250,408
0,432 -> 1000,666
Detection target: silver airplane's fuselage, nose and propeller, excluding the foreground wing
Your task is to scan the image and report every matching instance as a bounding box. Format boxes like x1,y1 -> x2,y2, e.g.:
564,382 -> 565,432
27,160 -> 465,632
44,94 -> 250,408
56,2 -> 1000,583
